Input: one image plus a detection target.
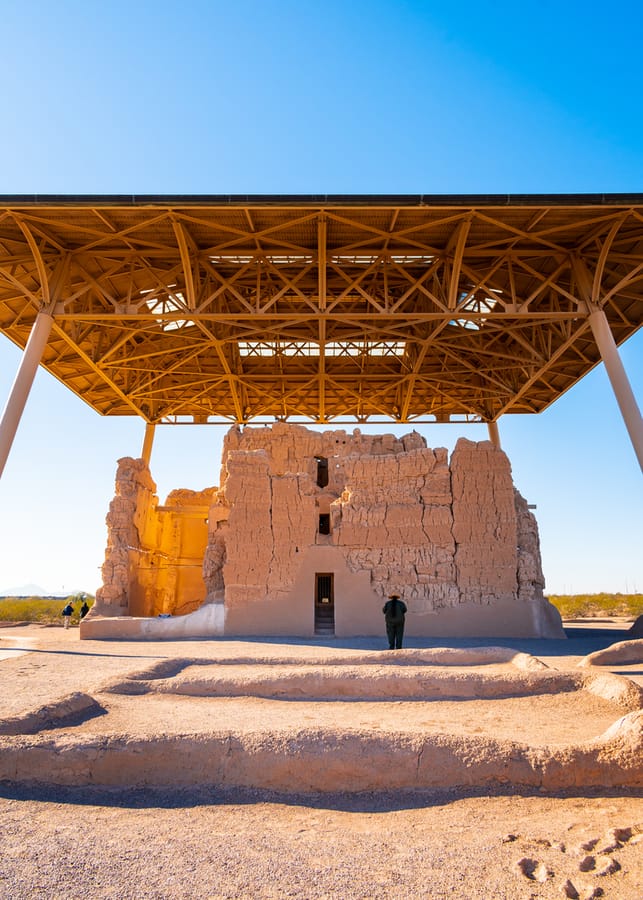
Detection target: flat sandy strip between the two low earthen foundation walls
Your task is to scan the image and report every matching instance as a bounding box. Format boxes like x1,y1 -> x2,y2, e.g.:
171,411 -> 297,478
83,692 -> 618,746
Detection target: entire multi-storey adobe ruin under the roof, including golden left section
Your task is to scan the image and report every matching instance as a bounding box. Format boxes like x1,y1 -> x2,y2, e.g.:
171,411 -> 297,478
81,423 -> 564,638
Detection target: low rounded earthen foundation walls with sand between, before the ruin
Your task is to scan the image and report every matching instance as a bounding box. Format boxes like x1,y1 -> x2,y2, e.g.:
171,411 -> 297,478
0,652 -> 643,792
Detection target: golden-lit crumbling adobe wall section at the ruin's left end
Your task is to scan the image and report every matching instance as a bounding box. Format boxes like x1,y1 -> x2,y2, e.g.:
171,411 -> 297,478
93,457 -> 213,616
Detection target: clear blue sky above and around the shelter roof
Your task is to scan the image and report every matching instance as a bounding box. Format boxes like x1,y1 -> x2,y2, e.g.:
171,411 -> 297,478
0,0 -> 643,592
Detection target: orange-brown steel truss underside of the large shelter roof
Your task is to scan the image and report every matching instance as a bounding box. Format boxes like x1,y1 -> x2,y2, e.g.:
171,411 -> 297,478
0,195 -> 643,423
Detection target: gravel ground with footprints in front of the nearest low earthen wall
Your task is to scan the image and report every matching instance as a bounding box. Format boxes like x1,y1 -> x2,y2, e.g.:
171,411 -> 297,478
0,786 -> 643,900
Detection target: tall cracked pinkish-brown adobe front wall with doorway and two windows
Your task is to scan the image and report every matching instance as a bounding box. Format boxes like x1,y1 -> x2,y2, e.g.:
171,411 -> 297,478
210,424 -> 562,636
